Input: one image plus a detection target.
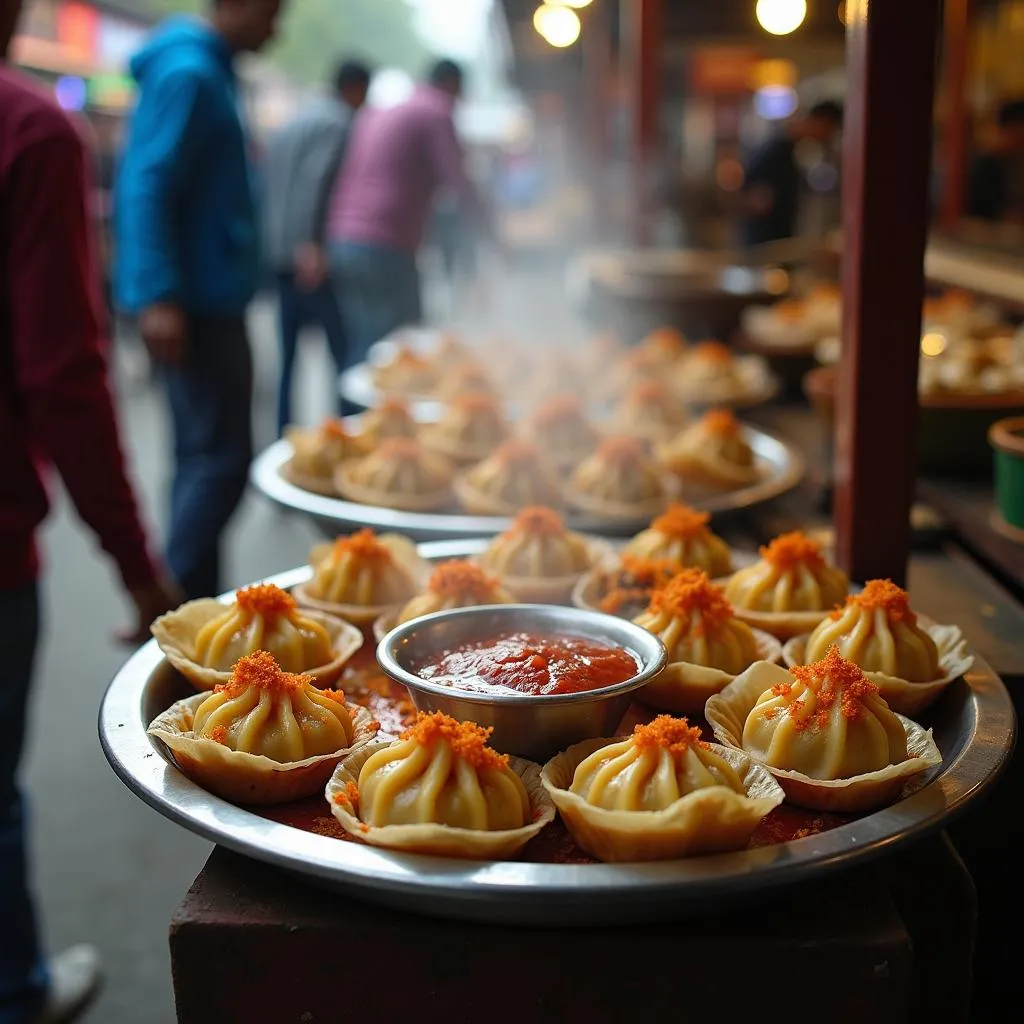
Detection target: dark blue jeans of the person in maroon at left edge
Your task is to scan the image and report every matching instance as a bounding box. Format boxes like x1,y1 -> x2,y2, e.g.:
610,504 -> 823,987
0,584 -> 48,1024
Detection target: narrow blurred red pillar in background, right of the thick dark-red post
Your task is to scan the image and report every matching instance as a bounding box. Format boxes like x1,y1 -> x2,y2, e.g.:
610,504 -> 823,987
940,0 -> 971,229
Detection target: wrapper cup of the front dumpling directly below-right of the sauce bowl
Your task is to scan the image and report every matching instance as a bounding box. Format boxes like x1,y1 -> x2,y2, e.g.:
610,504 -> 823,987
541,736 -> 784,862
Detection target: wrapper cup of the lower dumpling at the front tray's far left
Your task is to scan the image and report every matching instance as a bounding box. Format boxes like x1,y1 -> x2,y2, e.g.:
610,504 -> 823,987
147,693 -> 377,805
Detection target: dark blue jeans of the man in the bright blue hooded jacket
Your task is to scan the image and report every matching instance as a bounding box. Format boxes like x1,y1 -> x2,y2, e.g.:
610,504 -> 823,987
163,315 -> 253,600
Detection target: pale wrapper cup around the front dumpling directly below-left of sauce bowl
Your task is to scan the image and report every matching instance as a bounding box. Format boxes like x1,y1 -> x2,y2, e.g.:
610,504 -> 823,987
324,742 -> 555,860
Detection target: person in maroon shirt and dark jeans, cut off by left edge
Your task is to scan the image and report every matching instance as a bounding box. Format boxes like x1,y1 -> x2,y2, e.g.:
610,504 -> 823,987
0,0 -> 176,1024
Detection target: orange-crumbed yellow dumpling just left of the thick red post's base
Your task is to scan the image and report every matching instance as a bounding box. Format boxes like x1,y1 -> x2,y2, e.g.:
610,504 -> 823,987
725,530 -> 850,612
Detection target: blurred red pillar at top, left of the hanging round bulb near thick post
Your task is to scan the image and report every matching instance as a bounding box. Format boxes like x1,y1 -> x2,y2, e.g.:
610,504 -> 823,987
620,0 -> 665,245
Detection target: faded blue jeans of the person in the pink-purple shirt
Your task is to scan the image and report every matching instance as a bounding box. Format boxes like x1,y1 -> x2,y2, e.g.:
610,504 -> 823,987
331,242 -> 423,366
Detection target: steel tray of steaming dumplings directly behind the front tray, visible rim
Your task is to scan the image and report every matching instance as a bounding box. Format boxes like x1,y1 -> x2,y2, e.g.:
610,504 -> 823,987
250,426 -> 804,541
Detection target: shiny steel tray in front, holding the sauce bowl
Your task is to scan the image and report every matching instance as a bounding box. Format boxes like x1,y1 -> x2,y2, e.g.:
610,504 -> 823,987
99,561 -> 1016,926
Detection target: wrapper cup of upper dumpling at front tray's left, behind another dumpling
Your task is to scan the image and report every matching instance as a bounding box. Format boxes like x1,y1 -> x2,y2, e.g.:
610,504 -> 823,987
152,597 -> 364,690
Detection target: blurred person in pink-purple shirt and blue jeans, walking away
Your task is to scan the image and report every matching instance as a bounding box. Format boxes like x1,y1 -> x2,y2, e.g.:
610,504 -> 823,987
328,60 -> 489,365
